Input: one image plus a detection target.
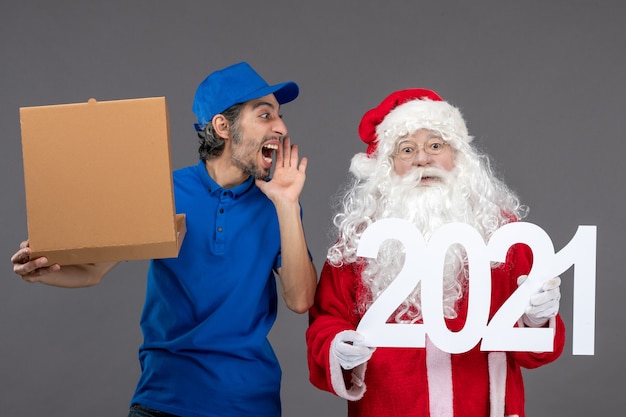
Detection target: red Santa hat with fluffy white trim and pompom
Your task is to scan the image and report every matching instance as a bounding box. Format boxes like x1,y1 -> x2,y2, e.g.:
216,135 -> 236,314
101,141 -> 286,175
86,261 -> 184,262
350,88 -> 473,178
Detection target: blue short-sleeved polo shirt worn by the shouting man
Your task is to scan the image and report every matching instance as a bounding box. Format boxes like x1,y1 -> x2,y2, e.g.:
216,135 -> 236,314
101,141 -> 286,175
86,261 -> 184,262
132,161 -> 281,417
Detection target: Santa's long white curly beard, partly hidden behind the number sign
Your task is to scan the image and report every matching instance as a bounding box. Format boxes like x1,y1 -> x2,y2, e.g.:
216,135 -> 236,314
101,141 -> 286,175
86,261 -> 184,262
362,169 -> 475,322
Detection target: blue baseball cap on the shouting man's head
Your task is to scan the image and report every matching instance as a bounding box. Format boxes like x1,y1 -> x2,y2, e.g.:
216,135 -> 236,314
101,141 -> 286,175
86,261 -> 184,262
192,62 -> 300,129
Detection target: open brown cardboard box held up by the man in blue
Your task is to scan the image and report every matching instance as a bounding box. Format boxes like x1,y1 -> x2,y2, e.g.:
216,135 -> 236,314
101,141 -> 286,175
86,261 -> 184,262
20,97 -> 186,265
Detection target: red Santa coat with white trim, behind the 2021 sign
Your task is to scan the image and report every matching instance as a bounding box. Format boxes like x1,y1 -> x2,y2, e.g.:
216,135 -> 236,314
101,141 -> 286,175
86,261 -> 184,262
306,245 -> 565,417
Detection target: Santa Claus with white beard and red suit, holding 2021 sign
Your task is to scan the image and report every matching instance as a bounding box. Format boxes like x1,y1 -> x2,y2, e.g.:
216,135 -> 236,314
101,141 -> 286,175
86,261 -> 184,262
306,89 -> 565,417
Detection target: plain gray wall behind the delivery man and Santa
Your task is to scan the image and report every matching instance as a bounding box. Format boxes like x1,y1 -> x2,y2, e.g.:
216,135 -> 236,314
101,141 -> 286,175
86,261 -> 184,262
0,0 -> 626,417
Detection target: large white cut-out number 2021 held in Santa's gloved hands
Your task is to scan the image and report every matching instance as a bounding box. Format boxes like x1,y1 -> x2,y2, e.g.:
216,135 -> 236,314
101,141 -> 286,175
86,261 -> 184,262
357,219 -> 596,355
